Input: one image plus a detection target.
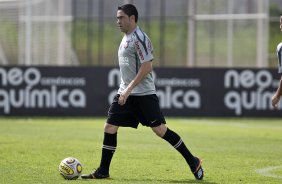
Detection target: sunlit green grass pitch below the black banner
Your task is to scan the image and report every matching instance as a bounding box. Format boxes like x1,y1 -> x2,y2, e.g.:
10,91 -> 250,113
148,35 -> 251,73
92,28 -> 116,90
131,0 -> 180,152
0,118 -> 282,184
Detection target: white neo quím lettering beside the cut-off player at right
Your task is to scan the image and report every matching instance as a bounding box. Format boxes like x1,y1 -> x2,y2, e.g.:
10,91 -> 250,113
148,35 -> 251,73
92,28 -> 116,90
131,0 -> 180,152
224,70 -> 276,115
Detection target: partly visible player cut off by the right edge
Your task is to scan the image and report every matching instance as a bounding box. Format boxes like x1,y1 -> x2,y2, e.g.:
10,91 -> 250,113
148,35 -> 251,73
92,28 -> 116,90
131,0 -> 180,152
271,14 -> 282,109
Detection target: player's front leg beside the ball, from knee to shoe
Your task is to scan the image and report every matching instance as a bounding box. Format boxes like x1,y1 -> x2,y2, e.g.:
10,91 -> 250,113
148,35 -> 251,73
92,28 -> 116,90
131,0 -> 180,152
81,123 -> 118,179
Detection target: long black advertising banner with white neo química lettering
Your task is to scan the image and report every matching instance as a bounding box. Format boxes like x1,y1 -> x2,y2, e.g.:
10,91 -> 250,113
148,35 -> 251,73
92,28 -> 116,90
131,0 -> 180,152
0,66 -> 282,117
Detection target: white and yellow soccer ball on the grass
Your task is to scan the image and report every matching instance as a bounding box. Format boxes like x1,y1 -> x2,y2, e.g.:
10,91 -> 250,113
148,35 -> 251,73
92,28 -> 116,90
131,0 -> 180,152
59,157 -> 82,180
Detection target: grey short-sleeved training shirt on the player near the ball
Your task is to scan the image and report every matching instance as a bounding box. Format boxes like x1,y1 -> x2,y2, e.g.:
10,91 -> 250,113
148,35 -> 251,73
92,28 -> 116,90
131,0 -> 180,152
118,26 -> 156,96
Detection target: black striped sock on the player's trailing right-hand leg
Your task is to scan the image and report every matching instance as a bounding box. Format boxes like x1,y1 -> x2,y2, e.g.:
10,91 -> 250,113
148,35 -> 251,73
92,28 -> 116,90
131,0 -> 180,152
163,128 -> 194,165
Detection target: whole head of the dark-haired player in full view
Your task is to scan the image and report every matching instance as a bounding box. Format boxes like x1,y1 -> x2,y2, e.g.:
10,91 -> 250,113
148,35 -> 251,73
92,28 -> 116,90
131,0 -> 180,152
117,4 -> 138,34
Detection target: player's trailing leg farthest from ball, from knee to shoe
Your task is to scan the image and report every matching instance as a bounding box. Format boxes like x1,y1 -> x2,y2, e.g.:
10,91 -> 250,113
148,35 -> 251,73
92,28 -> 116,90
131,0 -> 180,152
152,124 -> 204,180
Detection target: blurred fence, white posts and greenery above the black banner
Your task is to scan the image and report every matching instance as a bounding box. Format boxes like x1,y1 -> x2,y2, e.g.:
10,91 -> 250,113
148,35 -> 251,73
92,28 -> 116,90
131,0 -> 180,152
0,0 -> 282,67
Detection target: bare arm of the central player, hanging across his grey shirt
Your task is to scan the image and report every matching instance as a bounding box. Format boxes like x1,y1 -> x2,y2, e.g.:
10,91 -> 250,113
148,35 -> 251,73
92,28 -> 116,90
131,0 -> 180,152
118,61 -> 153,105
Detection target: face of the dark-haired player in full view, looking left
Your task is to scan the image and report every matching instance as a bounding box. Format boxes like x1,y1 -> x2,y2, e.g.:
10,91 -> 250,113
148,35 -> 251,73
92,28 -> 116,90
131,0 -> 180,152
117,10 -> 132,34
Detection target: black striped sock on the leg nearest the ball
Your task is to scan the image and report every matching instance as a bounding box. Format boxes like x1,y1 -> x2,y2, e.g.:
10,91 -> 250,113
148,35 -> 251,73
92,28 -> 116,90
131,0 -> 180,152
100,132 -> 117,174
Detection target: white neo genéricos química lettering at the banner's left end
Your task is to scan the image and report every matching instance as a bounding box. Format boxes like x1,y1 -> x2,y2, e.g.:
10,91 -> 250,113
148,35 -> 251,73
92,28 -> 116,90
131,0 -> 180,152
0,67 -> 86,114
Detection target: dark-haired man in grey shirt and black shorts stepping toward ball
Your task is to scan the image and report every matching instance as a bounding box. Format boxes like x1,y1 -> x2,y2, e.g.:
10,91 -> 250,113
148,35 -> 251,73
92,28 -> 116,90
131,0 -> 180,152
81,4 -> 204,180
